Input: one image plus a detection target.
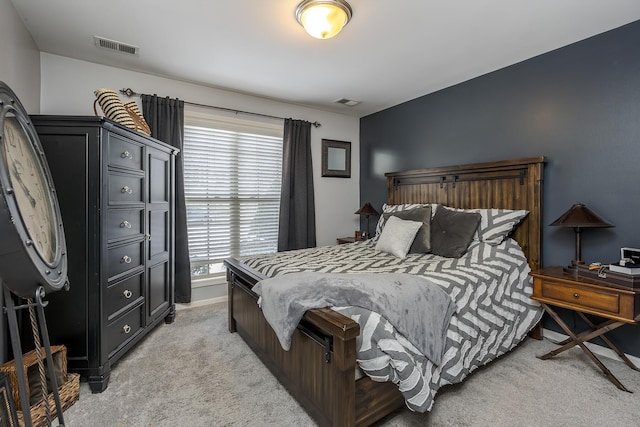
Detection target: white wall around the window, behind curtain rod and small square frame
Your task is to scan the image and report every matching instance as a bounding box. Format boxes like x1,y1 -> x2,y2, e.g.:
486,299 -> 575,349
40,53 -> 360,245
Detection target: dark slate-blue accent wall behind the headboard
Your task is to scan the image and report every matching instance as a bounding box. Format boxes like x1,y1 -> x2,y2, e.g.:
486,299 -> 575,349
360,21 -> 640,356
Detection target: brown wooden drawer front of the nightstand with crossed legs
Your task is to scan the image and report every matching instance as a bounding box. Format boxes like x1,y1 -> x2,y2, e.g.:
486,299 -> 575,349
541,280 -> 620,314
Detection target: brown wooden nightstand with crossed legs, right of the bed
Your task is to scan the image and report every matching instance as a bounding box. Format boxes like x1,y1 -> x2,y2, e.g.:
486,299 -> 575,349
531,267 -> 640,391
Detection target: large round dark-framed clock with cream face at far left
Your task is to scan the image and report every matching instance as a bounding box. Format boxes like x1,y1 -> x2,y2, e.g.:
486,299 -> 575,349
0,82 -> 68,298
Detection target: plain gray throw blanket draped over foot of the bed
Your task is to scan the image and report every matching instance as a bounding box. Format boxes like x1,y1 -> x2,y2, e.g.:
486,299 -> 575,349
253,272 -> 456,365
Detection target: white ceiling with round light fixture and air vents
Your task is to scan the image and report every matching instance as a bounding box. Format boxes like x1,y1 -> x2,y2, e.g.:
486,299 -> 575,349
11,0 -> 640,116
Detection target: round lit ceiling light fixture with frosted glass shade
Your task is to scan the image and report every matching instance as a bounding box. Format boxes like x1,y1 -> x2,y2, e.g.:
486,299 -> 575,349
296,0 -> 353,39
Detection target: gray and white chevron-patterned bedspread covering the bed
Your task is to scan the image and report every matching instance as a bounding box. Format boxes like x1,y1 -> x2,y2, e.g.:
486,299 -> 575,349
240,239 -> 542,412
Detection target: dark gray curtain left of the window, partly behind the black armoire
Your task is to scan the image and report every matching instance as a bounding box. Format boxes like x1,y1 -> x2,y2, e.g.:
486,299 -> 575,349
141,95 -> 191,303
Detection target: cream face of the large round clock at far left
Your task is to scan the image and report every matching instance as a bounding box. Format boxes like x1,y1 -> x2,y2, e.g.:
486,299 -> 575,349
2,112 -> 58,264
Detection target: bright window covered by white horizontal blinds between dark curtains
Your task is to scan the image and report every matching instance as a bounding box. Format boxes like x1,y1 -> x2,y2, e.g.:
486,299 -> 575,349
183,112 -> 282,279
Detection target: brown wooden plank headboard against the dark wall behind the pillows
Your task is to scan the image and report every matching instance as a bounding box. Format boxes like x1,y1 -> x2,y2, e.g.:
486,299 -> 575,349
385,156 -> 545,270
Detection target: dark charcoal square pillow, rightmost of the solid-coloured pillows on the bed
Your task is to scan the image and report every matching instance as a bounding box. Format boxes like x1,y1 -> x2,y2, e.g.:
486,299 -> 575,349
431,209 -> 481,258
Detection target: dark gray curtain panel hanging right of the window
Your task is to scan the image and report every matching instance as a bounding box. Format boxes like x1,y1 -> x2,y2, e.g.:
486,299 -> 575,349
278,119 -> 316,251
